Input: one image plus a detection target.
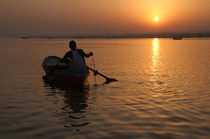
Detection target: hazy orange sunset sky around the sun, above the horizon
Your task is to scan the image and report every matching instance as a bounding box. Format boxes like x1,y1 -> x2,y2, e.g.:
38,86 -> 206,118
0,0 -> 210,36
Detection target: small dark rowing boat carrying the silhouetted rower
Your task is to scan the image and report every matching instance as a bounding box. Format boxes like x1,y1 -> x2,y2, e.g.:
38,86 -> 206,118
42,56 -> 89,87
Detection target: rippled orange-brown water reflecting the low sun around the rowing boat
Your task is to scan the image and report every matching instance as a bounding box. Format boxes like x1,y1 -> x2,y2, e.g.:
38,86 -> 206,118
0,39 -> 210,139
